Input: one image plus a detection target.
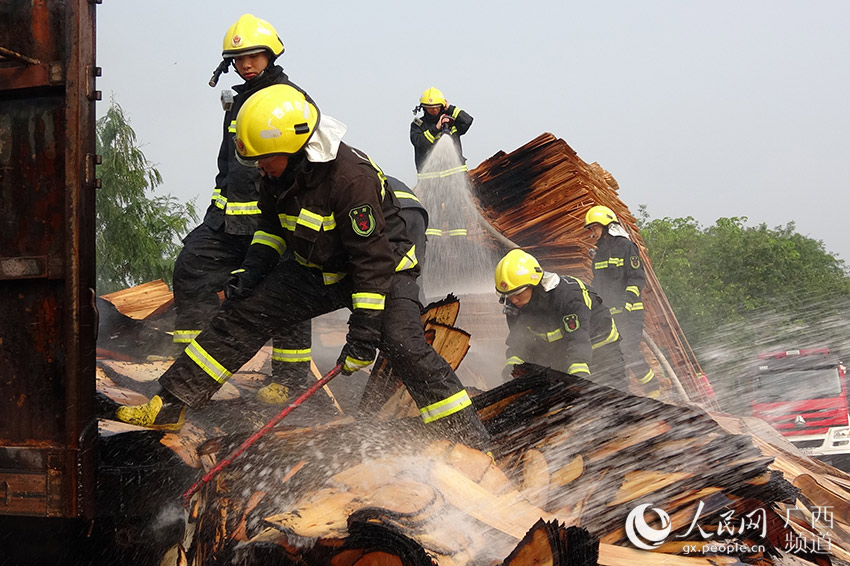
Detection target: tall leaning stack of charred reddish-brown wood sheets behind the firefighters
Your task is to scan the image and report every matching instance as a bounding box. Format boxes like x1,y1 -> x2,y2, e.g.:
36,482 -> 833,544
469,133 -> 718,409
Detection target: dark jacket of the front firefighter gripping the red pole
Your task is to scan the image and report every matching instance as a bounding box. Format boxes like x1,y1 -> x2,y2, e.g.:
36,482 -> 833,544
243,139 -> 419,320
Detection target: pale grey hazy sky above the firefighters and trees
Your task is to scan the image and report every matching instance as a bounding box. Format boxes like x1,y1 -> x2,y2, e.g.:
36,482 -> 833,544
97,0 -> 850,263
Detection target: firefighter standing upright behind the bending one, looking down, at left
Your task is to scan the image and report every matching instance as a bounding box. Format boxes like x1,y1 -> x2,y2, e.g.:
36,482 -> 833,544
173,14 -> 316,408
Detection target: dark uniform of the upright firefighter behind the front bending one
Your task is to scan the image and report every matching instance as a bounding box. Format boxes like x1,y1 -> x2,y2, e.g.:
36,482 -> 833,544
173,65 -> 315,392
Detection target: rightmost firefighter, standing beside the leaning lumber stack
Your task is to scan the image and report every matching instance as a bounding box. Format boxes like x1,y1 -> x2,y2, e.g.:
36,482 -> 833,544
584,205 -> 661,399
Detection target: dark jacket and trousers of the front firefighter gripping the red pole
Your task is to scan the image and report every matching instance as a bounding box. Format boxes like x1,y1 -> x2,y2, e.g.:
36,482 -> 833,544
160,143 -> 487,447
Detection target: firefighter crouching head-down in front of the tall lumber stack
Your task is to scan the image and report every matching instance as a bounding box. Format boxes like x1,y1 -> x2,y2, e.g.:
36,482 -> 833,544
495,249 -> 627,391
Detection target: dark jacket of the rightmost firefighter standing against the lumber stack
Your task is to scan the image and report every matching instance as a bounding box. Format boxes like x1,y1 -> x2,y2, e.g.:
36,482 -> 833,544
592,232 -> 646,320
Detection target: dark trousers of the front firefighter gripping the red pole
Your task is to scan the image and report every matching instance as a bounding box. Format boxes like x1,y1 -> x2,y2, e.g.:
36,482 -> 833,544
159,261 -> 487,448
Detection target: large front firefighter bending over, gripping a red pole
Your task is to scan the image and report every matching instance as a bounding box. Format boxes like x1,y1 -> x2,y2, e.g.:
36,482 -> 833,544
116,85 -> 489,448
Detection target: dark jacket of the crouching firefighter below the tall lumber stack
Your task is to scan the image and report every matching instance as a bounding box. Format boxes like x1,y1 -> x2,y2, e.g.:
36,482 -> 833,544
505,273 -> 619,377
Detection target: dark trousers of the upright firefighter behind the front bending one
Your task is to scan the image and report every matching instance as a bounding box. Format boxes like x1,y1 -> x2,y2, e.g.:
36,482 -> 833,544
173,224 -> 312,389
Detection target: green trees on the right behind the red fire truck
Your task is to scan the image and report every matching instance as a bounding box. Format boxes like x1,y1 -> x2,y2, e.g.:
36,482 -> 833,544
639,207 -> 850,411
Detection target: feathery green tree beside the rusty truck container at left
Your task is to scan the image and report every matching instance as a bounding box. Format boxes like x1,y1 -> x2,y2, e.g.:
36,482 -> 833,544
95,99 -> 197,294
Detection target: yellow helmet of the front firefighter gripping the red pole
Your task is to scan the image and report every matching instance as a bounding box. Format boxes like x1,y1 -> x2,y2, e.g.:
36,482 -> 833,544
236,84 -> 319,160
